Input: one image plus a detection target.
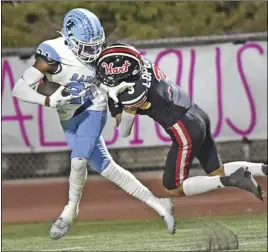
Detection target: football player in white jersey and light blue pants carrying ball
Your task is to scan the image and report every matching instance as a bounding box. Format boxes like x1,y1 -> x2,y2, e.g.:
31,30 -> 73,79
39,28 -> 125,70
13,8 -> 176,239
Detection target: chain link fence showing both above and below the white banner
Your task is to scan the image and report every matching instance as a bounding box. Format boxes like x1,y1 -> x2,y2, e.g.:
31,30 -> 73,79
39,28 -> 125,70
2,32 -> 267,180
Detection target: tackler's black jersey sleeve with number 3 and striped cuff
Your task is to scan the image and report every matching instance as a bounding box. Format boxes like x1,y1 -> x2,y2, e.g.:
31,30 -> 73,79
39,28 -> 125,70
118,79 -> 148,108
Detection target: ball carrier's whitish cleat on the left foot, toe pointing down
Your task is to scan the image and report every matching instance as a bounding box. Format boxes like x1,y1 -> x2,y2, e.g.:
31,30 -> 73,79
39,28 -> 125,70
49,206 -> 78,240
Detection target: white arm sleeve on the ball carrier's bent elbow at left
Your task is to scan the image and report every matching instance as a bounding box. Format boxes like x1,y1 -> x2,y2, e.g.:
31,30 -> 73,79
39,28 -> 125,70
12,66 -> 46,105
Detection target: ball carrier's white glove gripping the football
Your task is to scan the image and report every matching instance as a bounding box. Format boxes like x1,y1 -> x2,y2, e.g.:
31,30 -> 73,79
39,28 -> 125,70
49,86 -> 86,108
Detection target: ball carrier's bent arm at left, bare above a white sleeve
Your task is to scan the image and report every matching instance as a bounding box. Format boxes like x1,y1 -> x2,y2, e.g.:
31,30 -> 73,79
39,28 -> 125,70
12,58 -> 53,106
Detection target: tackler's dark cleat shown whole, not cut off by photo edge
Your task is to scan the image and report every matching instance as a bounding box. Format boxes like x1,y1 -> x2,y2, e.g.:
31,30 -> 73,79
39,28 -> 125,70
228,167 -> 264,201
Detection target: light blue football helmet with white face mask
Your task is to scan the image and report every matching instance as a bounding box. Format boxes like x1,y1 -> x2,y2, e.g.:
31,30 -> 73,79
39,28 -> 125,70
61,8 -> 105,63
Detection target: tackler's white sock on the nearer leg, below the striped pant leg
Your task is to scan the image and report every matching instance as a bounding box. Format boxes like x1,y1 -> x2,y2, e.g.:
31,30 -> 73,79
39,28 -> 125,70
182,176 -> 225,196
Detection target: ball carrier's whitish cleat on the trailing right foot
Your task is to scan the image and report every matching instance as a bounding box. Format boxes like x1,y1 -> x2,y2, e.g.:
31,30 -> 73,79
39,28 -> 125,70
160,198 -> 176,234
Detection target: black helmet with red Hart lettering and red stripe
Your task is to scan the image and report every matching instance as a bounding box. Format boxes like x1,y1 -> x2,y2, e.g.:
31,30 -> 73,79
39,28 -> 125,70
96,44 -> 142,87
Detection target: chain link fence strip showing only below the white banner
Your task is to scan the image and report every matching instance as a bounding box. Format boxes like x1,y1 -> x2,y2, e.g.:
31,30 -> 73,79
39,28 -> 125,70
2,139 -> 267,180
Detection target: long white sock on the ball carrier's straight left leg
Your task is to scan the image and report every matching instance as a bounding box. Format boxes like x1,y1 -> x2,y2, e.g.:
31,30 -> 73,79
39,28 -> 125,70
61,158 -> 87,218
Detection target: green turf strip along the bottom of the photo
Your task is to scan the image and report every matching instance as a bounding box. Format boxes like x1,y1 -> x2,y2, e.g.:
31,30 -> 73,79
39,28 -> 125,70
2,214 -> 267,251
